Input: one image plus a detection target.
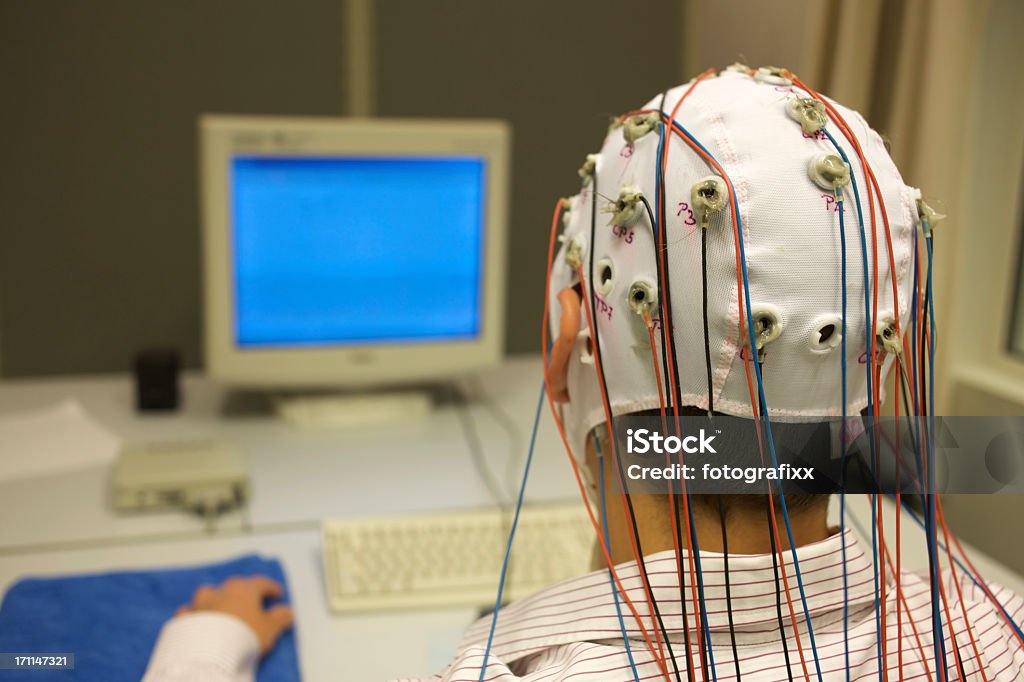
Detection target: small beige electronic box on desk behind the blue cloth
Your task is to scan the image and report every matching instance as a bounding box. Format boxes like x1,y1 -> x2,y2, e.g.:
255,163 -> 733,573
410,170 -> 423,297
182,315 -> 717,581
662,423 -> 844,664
113,439 -> 249,518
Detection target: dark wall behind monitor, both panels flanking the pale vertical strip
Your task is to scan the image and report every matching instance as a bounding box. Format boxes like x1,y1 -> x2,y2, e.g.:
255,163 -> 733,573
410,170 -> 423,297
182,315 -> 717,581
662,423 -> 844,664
0,0 -> 683,376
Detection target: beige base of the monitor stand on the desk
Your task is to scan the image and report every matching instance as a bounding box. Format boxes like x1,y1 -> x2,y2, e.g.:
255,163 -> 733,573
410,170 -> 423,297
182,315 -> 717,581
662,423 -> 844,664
273,388 -> 433,430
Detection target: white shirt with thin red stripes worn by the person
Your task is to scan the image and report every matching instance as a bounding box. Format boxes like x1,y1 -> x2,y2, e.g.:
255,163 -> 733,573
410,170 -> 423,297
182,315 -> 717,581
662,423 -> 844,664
145,530 -> 1024,682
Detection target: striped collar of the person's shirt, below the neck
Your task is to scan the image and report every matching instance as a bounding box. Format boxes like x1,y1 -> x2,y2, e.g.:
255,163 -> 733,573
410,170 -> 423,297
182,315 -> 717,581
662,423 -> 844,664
463,529 -> 876,662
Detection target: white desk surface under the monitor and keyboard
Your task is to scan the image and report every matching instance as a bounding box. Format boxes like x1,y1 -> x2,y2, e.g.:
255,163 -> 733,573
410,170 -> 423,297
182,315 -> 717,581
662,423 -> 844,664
0,356 -> 1024,682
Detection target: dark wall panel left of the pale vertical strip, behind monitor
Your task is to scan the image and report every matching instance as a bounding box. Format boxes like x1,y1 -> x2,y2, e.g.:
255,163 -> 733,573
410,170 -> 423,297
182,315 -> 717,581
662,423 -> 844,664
0,0 -> 343,376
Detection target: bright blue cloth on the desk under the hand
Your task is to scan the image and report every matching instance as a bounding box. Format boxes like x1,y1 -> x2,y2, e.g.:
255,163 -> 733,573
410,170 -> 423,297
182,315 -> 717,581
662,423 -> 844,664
0,554 -> 299,682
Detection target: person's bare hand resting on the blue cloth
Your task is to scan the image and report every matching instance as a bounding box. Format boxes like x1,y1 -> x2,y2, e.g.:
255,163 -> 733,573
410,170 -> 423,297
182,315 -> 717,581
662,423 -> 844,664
174,576 -> 295,654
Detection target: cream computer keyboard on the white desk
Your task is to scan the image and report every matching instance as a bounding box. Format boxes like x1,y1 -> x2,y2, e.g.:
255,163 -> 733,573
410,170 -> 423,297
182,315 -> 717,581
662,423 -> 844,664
323,502 -> 595,612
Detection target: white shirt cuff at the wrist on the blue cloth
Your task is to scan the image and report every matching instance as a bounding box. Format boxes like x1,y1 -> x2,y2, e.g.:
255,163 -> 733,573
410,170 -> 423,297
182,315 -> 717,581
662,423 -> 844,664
142,611 -> 260,682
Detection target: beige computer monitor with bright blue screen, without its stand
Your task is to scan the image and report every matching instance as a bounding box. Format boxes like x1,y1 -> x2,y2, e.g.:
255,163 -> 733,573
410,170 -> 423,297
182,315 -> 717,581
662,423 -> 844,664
200,115 -> 510,387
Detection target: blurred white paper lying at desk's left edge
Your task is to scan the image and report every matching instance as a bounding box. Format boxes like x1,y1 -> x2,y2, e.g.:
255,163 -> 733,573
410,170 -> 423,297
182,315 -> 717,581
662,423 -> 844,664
0,400 -> 120,482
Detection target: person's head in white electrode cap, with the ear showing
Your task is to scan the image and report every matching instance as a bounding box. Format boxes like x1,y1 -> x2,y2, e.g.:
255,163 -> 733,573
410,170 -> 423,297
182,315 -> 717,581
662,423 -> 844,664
547,68 -> 927,557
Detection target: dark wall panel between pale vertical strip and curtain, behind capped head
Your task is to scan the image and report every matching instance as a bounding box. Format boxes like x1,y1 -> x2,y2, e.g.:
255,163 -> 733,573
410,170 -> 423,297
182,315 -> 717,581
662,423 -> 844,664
376,0 -> 684,352
